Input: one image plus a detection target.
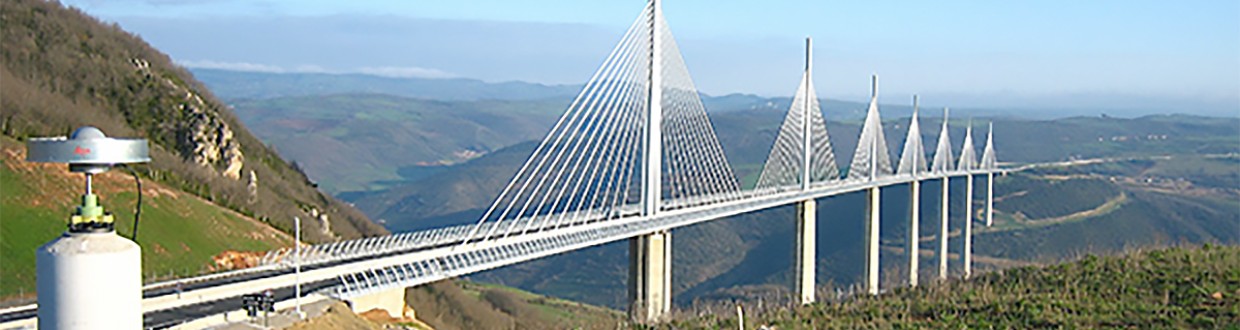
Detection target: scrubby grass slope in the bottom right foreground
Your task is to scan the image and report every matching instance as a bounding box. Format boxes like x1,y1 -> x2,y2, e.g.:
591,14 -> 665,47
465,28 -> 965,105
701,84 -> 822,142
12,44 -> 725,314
656,244 -> 1240,329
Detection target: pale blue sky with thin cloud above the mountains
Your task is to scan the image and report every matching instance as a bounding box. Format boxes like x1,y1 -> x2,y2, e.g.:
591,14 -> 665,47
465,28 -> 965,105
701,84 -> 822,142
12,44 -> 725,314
62,0 -> 1240,115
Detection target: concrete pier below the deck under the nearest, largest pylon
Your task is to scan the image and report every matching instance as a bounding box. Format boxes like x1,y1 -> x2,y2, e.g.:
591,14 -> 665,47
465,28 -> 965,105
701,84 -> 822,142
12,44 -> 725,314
629,231 -> 672,323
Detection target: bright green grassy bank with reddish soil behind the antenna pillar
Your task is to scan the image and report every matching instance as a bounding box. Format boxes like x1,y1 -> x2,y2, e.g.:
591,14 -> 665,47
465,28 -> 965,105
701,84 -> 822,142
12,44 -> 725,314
0,136 -> 293,301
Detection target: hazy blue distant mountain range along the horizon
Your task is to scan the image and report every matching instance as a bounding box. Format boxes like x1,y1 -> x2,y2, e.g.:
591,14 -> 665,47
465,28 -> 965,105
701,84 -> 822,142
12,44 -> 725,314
190,68 -> 1240,120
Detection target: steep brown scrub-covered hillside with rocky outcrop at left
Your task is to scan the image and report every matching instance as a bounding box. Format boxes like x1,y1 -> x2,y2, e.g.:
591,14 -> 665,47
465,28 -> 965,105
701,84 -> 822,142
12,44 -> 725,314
0,0 -> 384,241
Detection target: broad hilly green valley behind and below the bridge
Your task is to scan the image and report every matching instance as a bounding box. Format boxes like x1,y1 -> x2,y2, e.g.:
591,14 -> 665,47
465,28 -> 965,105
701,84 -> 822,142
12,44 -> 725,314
198,71 -> 1240,309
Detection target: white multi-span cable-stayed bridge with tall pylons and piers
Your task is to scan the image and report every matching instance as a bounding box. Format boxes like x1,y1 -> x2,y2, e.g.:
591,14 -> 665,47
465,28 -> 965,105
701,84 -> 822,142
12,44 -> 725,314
0,0 -> 1007,326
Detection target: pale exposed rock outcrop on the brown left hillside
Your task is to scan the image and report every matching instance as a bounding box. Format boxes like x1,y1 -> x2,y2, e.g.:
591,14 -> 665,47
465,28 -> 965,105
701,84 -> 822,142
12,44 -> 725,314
131,58 -> 246,180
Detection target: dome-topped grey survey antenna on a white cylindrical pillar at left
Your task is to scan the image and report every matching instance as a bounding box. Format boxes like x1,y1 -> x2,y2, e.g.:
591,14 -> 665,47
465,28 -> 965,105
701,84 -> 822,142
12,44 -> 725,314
26,127 -> 150,329
